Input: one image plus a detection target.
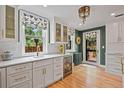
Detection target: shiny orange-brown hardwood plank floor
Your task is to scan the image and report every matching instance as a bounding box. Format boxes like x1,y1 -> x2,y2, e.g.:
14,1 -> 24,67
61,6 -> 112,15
49,64 -> 122,88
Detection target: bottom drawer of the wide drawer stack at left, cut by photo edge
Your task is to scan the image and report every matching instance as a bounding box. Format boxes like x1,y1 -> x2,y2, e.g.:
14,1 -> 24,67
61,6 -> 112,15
10,80 -> 32,88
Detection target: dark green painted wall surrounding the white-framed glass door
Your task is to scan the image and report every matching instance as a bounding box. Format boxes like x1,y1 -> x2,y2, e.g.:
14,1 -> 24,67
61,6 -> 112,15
75,26 -> 106,65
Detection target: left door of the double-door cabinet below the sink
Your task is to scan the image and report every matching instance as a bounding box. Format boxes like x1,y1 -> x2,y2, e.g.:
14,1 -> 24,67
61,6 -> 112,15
33,67 -> 44,88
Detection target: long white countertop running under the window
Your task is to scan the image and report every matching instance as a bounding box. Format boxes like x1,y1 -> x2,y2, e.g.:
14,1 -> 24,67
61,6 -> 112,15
0,53 -> 70,68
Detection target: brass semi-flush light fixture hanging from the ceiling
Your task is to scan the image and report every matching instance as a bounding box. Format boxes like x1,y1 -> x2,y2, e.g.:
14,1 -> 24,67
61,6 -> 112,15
78,6 -> 90,23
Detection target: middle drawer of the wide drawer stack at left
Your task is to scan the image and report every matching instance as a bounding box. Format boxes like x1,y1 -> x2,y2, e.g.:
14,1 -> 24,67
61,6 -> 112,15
7,70 -> 32,87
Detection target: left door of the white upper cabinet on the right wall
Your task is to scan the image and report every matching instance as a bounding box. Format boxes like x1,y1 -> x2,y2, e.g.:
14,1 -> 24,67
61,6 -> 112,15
106,23 -> 118,43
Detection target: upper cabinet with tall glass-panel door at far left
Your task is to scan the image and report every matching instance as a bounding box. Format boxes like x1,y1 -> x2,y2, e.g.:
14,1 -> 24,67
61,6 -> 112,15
0,5 -> 18,40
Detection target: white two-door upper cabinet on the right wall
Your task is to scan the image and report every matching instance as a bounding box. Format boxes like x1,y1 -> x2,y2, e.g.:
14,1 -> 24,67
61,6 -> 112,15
106,21 -> 124,43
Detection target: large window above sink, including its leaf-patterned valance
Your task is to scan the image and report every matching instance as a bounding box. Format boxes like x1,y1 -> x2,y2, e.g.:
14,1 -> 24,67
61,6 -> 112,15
20,10 -> 49,53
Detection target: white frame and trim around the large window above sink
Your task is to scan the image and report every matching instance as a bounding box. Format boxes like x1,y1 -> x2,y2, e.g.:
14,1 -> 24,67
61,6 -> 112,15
18,9 -> 50,56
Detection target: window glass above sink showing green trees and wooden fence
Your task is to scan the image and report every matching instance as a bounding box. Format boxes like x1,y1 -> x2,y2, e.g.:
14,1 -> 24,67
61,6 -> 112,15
25,26 -> 43,53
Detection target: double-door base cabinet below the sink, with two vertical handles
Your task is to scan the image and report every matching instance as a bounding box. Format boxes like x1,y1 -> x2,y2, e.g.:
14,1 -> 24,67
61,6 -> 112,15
33,59 -> 54,88
